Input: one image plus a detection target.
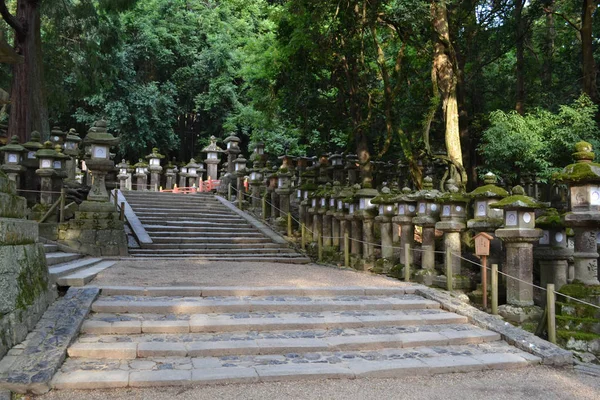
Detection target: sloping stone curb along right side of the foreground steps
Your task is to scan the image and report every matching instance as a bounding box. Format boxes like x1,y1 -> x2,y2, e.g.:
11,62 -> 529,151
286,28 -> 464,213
416,286 -> 573,366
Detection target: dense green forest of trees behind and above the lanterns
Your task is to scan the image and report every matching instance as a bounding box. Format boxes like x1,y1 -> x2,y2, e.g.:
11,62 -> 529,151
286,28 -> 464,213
0,0 -> 600,186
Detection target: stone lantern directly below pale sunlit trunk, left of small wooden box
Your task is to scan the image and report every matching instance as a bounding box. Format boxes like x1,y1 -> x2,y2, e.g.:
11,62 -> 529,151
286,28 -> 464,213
435,179 -> 471,289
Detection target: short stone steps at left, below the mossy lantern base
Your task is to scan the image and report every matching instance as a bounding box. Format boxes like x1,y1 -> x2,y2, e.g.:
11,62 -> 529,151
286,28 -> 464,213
44,244 -> 116,286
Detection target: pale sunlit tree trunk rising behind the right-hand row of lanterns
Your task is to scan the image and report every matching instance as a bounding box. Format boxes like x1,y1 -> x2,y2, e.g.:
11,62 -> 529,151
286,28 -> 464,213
431,0 -> 467,185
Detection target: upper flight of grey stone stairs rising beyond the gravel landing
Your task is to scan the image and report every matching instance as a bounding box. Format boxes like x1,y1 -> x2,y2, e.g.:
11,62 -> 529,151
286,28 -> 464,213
123,192 -> 309,263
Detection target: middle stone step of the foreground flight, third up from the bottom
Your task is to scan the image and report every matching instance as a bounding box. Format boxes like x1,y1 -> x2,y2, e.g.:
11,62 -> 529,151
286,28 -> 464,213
81,310 -> 468,335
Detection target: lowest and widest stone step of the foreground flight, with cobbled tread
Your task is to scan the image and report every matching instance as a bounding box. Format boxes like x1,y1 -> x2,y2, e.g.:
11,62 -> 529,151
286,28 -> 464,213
52,342 -> 541,389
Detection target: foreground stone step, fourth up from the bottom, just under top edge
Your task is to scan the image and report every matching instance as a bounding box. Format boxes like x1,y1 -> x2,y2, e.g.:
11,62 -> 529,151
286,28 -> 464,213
92,295 -> 440,314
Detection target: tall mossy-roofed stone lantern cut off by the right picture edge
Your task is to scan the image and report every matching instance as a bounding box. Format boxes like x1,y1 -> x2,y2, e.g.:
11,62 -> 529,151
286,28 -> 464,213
555,142 -> 600,285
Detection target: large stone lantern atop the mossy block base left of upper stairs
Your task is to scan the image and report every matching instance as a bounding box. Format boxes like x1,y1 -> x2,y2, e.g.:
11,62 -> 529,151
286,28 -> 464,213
84,120 -> 119,202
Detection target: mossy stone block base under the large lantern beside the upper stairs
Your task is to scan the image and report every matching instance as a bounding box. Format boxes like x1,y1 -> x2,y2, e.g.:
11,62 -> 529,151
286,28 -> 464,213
58,201 -> 128,257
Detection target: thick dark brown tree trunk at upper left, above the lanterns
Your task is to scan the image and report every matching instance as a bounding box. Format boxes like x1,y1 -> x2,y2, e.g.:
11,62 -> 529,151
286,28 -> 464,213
8,0 -> 50,142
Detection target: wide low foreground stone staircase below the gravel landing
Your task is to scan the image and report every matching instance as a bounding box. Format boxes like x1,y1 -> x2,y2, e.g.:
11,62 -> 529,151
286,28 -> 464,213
52,286 -> 540,389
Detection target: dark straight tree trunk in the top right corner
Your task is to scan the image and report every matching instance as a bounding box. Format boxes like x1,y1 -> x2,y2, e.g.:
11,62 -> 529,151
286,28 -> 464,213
580,0 -> 598,103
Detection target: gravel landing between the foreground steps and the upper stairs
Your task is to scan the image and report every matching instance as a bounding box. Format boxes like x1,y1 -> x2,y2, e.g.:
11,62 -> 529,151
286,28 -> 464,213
90,259 -> 404,287
